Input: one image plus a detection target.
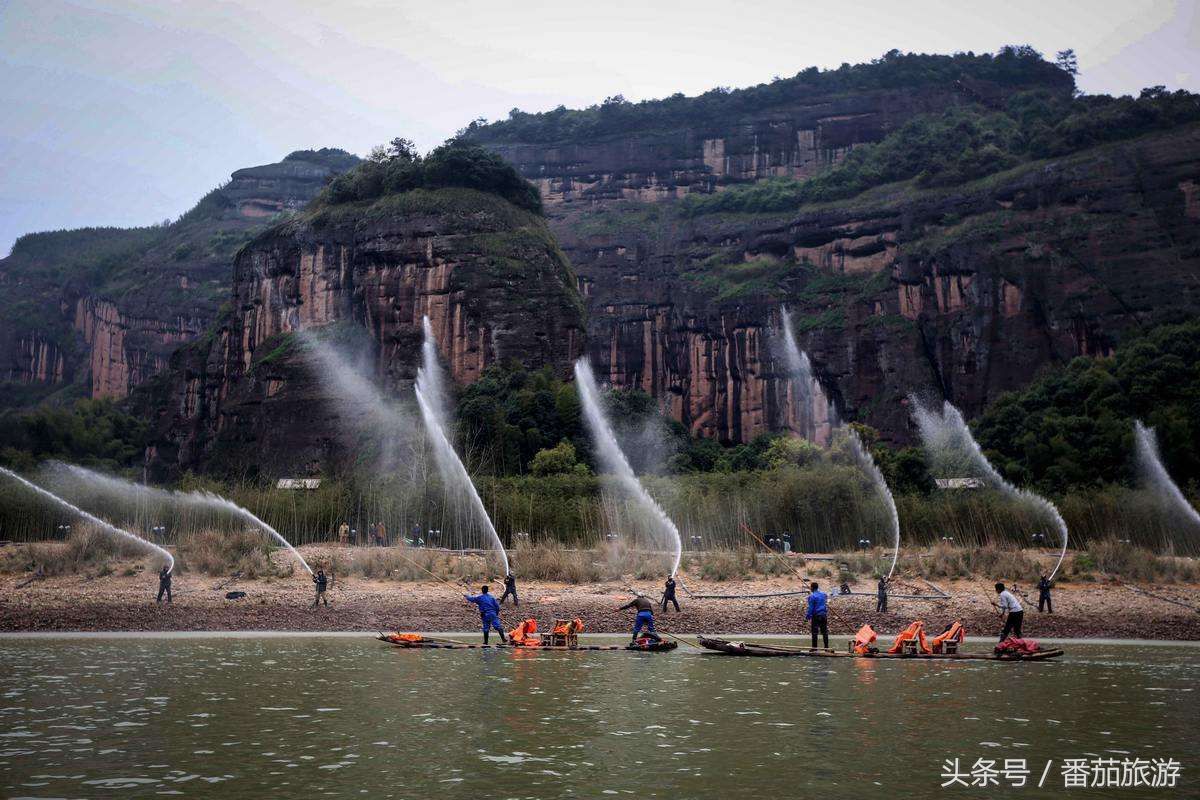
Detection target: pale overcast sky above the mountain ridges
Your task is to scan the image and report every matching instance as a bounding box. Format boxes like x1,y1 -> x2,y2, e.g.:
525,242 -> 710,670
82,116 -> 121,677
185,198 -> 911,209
0,0 -> 1200,254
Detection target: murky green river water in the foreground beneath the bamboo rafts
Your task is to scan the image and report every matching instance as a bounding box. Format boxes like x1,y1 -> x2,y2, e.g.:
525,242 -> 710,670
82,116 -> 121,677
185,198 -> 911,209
0,636 -> 1200,800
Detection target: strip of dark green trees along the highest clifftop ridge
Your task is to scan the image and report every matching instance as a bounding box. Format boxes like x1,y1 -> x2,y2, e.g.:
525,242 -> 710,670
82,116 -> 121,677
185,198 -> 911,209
461,47 -> 1074,144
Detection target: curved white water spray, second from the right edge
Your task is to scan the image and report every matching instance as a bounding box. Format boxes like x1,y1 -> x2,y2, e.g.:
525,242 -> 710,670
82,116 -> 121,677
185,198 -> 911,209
908,397 -> 1068,579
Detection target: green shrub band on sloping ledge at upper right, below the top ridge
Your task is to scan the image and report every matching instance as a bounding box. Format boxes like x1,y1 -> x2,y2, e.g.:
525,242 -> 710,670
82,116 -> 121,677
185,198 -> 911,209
683,86 -> 1200,216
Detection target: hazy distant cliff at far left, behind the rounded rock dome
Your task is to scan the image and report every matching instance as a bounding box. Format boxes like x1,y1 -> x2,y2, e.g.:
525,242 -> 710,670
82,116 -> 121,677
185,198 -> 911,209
0,151 -> 356,407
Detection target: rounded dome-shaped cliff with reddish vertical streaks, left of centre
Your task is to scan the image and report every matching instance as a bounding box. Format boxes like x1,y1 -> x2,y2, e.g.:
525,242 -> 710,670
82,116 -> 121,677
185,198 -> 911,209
151,188 -> 583,474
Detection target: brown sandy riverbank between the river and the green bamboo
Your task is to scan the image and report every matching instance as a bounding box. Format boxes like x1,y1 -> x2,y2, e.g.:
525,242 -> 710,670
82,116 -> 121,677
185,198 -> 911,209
0,561 -> 1200,639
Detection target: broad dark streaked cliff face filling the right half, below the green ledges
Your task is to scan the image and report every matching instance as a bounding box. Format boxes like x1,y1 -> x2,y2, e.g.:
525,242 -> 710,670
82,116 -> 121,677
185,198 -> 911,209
477,116 -> 1200,441
